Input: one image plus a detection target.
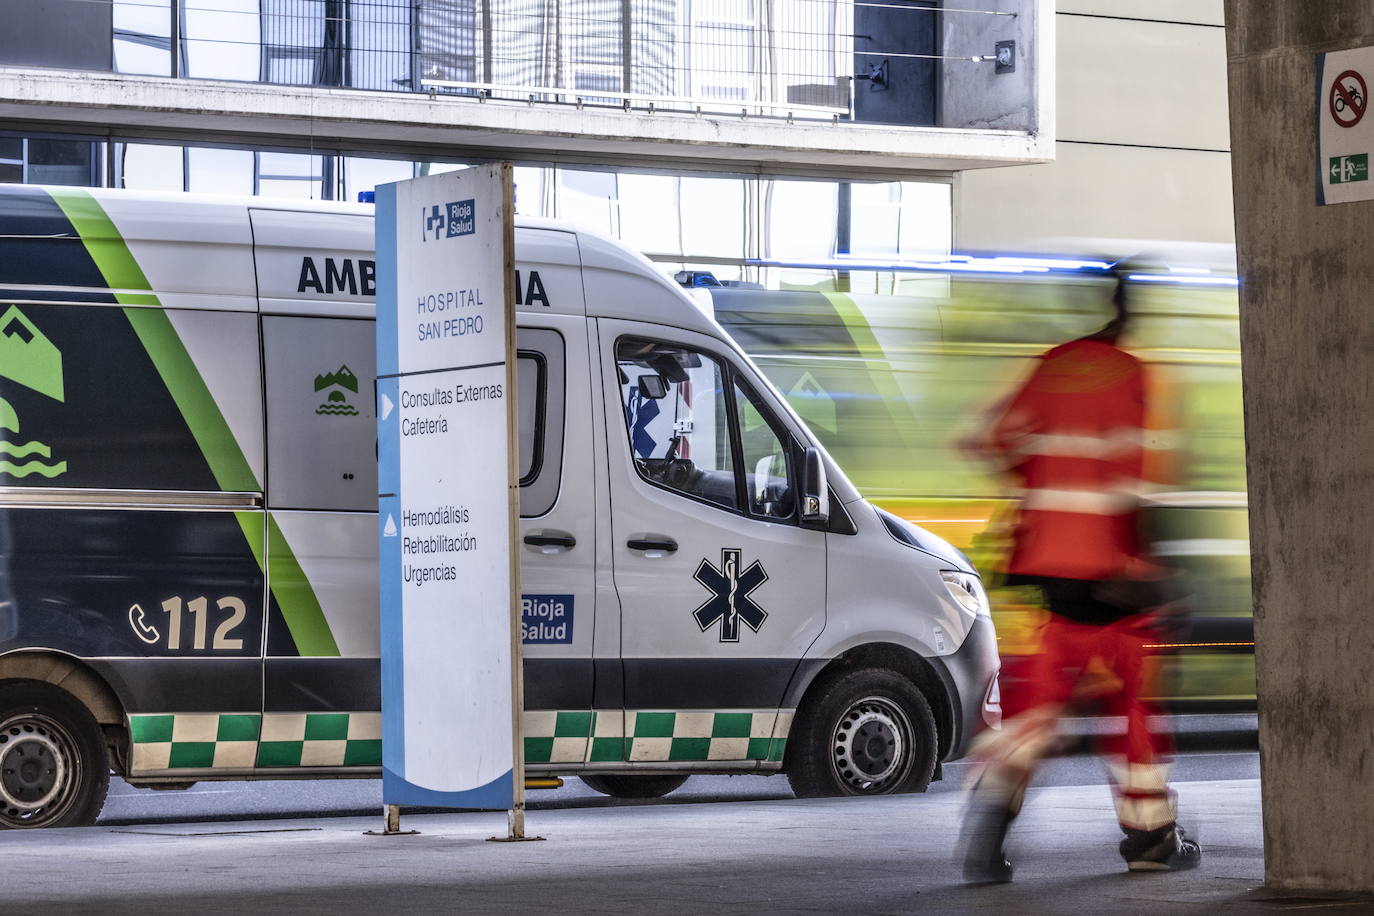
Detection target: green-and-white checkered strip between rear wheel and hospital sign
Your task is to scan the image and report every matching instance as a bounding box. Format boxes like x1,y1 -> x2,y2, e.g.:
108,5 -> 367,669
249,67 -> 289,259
129,713 -> 382,773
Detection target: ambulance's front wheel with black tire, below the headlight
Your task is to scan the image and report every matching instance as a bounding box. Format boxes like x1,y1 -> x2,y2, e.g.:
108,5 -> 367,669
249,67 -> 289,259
783,669 -> 938,798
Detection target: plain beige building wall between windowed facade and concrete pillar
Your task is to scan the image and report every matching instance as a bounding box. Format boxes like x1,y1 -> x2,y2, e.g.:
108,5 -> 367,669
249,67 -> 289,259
947,0 -> 1234,255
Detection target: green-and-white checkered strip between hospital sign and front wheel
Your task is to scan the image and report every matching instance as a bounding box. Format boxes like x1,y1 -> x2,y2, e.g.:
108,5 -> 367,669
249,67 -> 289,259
525,710 -> 793,764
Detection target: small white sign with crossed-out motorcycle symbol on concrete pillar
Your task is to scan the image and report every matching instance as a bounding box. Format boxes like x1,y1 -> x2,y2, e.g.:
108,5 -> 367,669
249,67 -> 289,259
1316,48 -> 1374,203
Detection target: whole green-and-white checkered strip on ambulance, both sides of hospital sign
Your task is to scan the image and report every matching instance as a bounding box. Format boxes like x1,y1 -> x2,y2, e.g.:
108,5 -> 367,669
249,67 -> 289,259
129,710 -> 794,776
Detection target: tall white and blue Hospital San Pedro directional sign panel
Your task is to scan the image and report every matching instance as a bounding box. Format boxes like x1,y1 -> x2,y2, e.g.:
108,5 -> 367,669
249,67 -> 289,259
376,166 -> 519,809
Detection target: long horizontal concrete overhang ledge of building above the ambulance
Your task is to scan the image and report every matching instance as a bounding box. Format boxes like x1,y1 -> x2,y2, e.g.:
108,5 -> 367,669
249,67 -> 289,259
0,67 -> 1054,179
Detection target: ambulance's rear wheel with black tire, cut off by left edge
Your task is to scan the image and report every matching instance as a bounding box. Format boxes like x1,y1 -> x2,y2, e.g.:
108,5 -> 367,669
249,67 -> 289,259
0,681 -> 110,829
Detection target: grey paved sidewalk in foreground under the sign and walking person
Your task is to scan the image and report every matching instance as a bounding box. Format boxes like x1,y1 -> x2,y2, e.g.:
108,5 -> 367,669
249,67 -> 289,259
13,779 -> 1370,916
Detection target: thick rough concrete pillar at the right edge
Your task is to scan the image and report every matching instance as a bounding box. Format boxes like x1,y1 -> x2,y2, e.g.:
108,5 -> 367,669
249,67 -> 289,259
1231,0 -> 1374,890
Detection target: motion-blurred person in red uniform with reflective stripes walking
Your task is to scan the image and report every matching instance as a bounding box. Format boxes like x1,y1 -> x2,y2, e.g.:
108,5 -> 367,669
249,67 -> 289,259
963,275 -> 1202,882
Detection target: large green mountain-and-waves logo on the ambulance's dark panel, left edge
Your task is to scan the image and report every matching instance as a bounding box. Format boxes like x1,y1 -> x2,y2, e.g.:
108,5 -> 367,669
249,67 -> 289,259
0,305 -> 67,479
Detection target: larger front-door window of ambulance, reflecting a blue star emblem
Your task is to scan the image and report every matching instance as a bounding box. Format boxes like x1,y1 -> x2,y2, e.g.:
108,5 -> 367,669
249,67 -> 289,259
616,339 -> 739,509
